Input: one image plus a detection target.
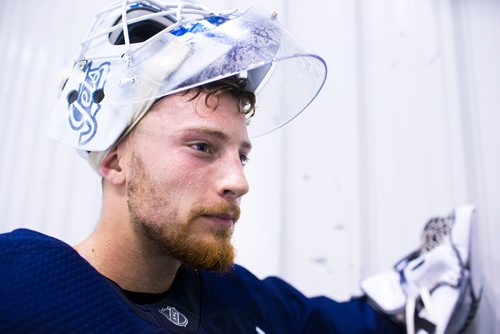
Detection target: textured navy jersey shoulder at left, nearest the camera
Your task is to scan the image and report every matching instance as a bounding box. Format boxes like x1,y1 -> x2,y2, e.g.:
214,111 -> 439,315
0,229 -> 156,333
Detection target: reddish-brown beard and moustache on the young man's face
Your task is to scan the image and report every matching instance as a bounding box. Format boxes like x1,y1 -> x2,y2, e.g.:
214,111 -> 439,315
127,155 -> 240,272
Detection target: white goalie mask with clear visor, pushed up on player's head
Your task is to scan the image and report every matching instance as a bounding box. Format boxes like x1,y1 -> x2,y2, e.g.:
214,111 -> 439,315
48,0 -> 327,168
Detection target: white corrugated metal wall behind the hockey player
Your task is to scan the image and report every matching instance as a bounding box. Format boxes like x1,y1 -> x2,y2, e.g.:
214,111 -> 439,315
0,0 -> 500,333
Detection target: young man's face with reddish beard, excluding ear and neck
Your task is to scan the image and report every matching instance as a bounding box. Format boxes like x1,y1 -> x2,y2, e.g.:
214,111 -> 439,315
119,93 -> 250,271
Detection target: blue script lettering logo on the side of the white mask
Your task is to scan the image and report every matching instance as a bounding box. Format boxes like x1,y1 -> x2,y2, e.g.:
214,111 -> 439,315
69,62 -> 110,146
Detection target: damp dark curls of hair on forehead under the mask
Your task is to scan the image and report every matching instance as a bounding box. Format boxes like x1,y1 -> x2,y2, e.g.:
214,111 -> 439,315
185,76 -> 256,118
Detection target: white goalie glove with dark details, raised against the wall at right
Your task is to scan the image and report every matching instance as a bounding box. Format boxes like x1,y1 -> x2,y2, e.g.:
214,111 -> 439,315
361,205 -> 480,334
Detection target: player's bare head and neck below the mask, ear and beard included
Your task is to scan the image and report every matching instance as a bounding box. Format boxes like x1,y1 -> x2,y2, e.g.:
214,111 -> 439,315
75,92 -> 251,293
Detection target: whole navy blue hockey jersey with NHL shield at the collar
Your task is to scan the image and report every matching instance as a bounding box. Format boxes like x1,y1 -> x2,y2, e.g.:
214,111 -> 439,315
0,229 -> 402,334
